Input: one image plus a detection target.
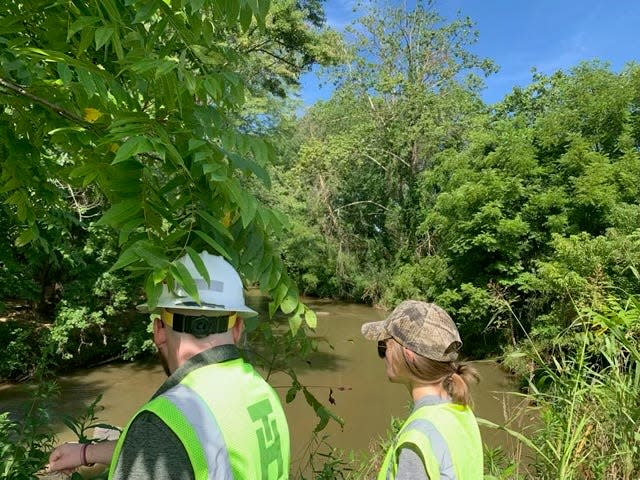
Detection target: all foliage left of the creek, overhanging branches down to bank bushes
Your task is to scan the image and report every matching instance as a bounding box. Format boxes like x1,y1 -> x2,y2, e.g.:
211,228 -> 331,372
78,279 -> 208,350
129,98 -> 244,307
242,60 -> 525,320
0,0 -> 339,378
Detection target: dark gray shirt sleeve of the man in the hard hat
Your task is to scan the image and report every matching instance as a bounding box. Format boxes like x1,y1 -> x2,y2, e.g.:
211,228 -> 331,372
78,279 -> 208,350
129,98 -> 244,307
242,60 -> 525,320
113,412 -> 195,480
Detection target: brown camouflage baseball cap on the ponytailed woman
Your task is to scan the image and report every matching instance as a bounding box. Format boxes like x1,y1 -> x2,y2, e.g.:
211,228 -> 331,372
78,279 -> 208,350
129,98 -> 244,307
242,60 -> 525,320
362,300 -> 462,362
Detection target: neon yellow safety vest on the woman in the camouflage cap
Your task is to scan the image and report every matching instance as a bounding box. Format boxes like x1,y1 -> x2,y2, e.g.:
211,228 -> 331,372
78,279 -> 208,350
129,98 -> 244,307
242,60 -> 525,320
378,403 -> 484,480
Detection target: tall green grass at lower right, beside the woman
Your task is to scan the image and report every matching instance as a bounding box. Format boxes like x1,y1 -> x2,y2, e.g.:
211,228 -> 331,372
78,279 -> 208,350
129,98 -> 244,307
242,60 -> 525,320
482,296 -> 640,480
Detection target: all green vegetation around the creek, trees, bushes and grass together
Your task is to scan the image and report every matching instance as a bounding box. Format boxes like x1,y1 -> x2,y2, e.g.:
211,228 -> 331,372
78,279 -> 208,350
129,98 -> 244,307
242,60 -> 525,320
0,0 -> 640,479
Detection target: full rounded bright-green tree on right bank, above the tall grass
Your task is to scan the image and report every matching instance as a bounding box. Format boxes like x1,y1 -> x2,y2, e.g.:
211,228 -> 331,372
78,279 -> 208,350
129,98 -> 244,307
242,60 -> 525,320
419,62 -> 640,349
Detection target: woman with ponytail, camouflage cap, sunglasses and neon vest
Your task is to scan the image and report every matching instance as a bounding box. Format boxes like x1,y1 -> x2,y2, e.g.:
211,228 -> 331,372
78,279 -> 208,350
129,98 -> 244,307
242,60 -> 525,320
362,300 -> 483,480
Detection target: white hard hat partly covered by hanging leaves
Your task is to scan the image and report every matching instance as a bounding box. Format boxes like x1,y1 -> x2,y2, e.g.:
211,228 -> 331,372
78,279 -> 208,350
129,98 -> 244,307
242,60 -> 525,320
138,251 -> 258,317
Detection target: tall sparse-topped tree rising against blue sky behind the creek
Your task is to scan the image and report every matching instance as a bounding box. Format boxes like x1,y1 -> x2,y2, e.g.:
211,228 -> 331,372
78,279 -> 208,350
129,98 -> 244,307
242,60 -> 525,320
280,2 -> 494,302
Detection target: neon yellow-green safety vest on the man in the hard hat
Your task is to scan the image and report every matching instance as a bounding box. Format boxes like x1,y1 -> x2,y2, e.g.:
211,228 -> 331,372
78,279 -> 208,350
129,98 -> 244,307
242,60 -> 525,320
109,358 -> 290,480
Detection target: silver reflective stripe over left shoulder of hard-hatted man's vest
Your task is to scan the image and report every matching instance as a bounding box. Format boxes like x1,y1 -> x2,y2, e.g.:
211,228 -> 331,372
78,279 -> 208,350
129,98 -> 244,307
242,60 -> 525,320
162,384 -> 233,480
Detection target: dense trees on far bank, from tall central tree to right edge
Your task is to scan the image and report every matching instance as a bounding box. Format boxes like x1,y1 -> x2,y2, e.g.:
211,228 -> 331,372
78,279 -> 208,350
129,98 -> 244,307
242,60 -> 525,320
277,4 -> 640,355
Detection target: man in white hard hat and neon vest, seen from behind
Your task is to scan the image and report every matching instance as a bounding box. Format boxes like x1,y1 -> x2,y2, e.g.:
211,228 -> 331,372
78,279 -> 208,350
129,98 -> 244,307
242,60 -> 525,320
49,252 -> 290,480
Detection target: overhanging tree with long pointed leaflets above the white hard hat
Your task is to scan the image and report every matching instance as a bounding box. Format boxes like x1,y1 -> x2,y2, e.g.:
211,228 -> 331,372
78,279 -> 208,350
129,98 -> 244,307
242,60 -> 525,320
0,0 -> 330,330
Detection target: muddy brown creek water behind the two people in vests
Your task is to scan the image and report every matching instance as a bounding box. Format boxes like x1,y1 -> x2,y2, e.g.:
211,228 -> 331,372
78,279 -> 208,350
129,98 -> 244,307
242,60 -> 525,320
0,300 -> 515,474
